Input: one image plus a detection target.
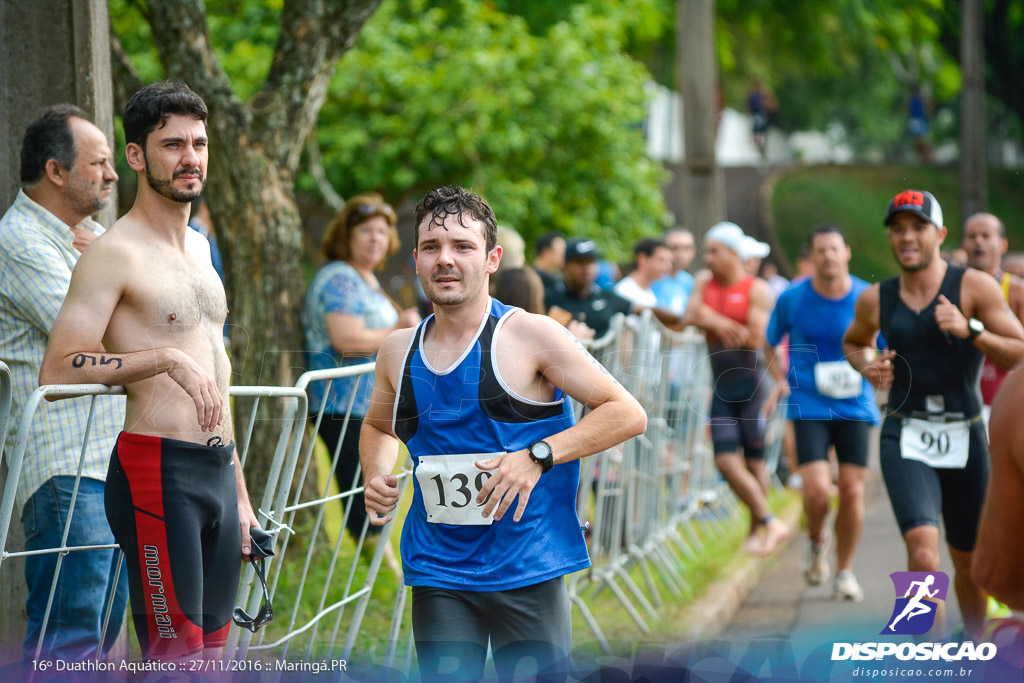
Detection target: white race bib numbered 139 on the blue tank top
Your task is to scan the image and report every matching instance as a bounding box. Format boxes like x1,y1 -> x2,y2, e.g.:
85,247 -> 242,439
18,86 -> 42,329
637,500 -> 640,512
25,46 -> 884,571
416,453 -> 505,525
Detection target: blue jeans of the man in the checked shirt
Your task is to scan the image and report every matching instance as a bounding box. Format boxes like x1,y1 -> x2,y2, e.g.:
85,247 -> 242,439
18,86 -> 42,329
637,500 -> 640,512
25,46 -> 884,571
22,476 -> 128,660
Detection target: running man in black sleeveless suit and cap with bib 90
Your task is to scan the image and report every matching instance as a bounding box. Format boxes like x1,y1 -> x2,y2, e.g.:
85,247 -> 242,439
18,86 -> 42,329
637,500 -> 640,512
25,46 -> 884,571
843,189 -> 1024,638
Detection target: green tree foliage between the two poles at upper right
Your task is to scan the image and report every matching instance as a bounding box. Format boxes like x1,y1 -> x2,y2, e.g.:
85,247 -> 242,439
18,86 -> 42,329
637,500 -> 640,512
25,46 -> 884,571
717,0 -> 959,153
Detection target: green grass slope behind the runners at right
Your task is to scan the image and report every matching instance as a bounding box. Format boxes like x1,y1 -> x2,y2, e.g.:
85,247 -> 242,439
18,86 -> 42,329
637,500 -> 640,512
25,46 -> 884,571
772,166 -> 1024,282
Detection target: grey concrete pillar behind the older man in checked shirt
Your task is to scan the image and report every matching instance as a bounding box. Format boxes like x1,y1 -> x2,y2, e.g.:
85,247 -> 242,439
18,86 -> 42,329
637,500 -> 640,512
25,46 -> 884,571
0,0 -> 117,655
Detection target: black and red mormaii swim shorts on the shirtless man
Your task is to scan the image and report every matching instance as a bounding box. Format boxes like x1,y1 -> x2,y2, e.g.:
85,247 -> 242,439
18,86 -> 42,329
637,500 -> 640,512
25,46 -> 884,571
104,432 -> 242,658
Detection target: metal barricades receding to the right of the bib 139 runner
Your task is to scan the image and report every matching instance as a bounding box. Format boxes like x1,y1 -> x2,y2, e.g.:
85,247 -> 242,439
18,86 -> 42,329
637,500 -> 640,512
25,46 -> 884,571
568,311 -> 783,652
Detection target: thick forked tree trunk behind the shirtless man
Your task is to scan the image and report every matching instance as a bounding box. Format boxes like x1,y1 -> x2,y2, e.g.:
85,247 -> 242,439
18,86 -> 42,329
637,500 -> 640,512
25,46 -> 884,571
109,0 -> 381,491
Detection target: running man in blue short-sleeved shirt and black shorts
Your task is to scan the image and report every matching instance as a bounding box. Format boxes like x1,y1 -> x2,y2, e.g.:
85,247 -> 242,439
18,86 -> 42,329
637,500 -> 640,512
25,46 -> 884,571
765,224 -> 879,602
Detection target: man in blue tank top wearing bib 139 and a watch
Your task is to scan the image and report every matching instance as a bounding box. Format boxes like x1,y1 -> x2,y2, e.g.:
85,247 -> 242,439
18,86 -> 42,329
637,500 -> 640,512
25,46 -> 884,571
359,187 -> 646,681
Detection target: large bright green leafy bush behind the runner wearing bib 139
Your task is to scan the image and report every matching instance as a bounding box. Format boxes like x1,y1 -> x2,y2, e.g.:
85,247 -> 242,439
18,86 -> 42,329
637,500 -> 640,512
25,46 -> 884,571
302,1 -> 666,256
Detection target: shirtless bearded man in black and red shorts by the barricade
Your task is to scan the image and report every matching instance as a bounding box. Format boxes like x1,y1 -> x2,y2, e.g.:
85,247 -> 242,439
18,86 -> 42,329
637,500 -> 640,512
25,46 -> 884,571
39,82 -> 257,658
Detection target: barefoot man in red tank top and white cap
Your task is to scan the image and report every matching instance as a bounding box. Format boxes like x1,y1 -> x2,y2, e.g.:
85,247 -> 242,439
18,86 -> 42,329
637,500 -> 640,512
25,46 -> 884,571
687,222 -> 790,555
